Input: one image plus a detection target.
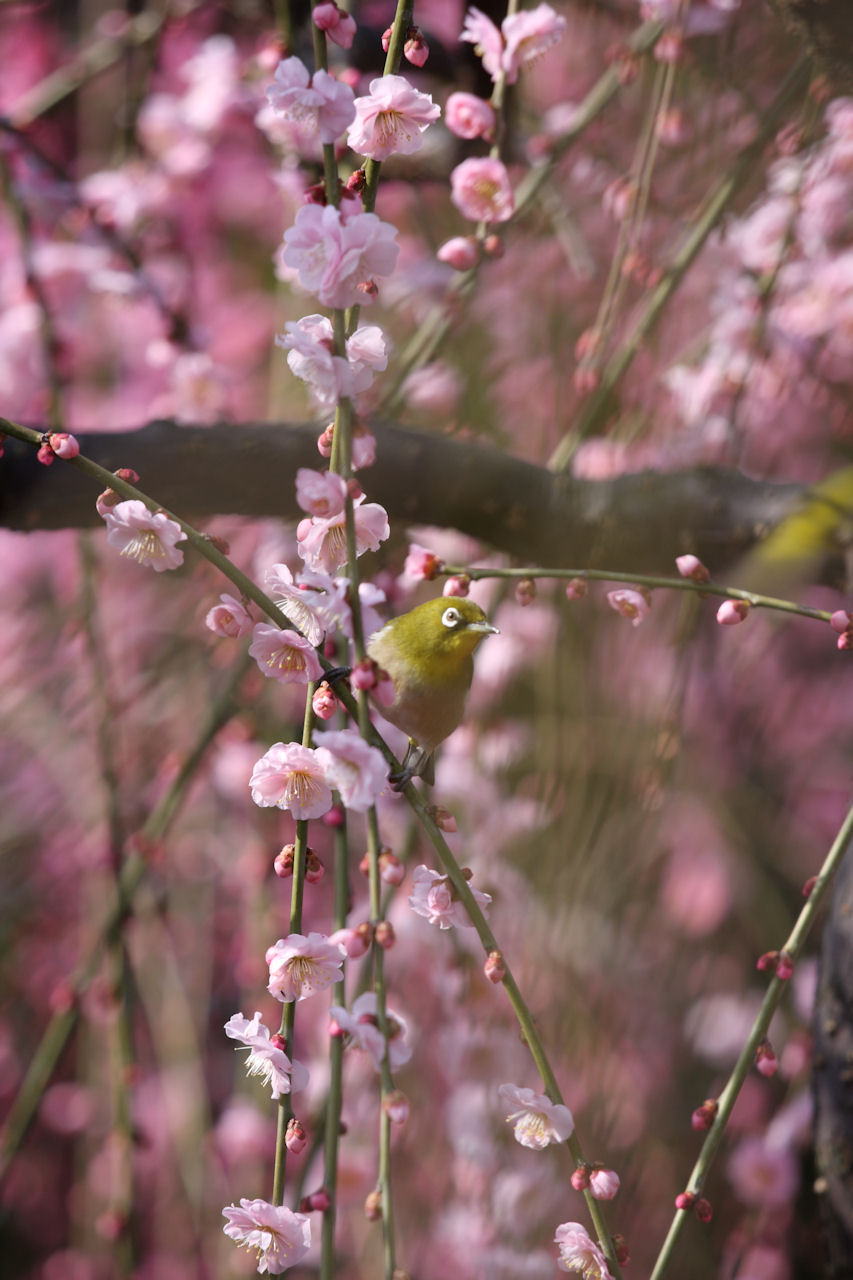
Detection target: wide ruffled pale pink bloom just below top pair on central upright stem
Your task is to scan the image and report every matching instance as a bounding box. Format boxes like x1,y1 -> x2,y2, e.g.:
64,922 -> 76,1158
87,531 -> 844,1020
283,205 -> 400,307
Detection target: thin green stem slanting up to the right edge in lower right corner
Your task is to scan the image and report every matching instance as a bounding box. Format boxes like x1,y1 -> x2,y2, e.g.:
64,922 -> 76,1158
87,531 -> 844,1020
652,805 -> 853,1280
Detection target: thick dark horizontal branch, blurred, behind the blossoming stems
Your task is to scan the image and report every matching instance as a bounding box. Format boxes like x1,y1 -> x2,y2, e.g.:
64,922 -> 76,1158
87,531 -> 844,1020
0,421 -> 803,572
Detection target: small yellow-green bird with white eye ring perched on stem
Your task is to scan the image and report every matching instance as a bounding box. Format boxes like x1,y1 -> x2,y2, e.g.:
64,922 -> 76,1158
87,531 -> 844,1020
368,596 -> 497,773
